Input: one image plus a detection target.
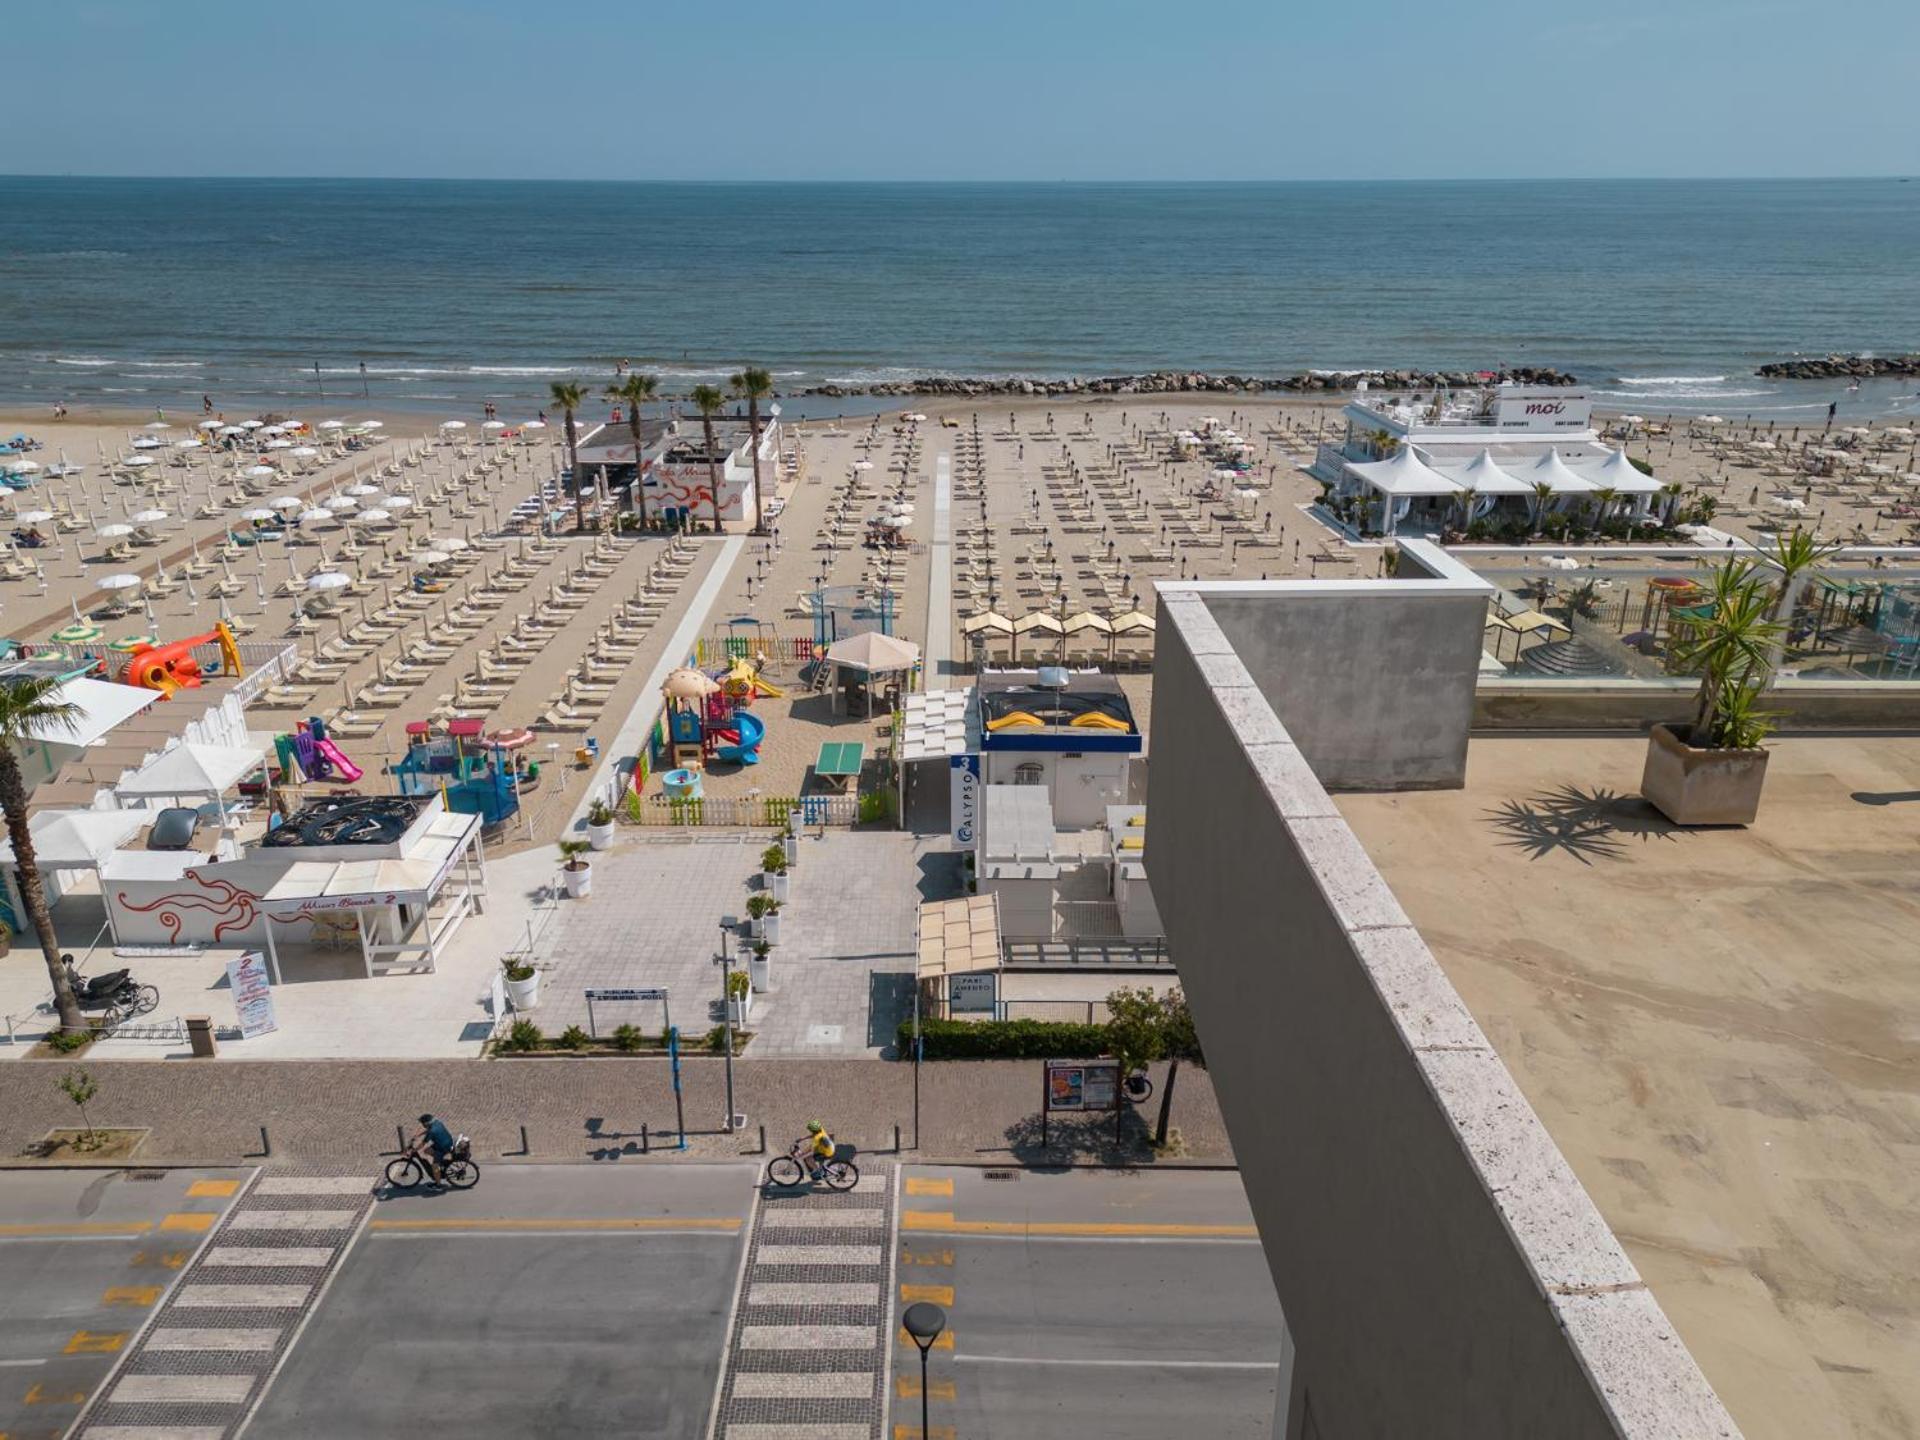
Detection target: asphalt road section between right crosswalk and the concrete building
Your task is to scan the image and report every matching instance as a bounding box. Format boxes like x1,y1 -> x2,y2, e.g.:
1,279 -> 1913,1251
891,1165 -> 1281,1440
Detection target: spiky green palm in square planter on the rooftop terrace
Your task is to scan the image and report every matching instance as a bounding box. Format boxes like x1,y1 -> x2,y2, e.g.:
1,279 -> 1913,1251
1640,559 -> 1784,826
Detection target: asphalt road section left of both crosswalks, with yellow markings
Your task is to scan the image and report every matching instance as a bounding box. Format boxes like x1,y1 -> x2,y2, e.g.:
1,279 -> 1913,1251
0,1169 -> 246,1440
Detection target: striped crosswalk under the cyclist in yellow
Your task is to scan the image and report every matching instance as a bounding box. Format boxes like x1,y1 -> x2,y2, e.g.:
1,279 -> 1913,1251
712,1165 -> 893,1440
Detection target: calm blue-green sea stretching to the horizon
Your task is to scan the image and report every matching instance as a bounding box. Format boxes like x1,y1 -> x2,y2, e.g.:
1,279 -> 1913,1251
0,179 -> 1920,415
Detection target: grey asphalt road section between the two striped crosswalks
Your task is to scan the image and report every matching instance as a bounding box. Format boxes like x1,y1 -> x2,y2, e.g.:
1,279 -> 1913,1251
246,1165 -> 756,1440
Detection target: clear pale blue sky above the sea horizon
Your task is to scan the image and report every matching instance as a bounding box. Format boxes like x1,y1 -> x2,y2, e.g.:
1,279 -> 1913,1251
0,0 -> 1920,180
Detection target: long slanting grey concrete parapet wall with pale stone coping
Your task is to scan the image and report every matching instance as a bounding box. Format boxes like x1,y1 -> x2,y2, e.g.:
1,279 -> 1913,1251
1146,591 -> 1738,1440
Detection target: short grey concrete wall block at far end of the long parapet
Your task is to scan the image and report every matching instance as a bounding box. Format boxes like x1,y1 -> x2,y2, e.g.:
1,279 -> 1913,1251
1154,541 -> 1494,789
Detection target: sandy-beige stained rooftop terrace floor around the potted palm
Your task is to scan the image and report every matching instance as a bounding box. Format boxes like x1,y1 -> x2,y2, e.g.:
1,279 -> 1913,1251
1336,737 -> 1920,1436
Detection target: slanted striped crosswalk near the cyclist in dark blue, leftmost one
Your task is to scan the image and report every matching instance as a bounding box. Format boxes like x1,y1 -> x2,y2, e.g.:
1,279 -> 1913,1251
71,1173 -> 374,1440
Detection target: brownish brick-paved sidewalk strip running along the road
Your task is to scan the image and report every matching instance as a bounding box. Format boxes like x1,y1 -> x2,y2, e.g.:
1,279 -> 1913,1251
0,1056 -> 1233,1173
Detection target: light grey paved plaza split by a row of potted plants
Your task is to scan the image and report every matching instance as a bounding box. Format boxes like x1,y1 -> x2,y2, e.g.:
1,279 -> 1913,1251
532,829 -> 958,1056
